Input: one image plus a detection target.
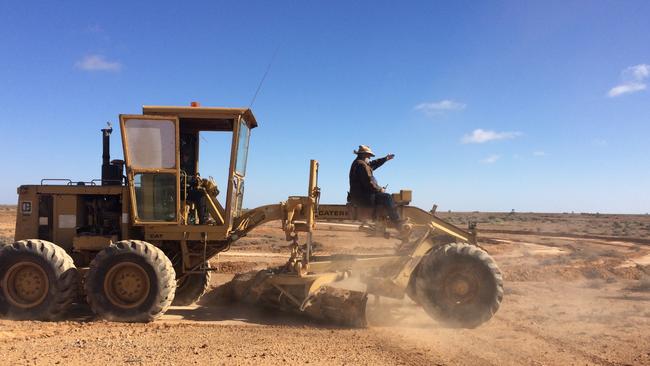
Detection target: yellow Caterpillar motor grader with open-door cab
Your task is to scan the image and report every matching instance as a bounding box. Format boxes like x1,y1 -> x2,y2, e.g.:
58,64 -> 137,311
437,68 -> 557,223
0,103 -> 503,327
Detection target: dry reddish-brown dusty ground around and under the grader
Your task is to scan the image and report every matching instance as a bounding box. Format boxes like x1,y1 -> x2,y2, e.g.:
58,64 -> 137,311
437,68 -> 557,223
0,206 -> 650,365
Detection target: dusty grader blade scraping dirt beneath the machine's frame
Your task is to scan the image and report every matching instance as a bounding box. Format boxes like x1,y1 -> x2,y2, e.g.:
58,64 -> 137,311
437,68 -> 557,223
230,270 -> 368,327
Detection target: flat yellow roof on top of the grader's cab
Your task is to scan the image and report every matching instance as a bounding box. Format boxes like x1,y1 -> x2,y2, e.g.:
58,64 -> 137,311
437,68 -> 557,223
142,105 -> 257,130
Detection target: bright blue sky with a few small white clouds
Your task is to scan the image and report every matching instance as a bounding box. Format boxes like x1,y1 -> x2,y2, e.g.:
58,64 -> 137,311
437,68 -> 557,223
0,1 -> 650,213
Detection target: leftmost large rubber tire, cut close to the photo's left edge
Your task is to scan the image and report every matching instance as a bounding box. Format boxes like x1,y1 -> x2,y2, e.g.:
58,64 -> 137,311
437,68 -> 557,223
0,239 -> 79,320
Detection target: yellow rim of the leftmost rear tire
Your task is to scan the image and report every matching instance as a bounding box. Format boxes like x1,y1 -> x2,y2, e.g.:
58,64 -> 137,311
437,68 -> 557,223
2,262 -> 50,309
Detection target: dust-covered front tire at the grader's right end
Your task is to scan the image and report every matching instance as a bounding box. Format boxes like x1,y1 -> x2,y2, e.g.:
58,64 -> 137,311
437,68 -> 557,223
411,243 -> 503,328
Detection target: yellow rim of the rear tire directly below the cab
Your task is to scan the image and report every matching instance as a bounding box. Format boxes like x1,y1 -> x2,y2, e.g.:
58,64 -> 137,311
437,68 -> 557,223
104,262 -> 151,309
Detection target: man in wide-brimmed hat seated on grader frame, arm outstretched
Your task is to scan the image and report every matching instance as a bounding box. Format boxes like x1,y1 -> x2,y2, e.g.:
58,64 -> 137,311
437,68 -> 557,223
348,145 -> 400,226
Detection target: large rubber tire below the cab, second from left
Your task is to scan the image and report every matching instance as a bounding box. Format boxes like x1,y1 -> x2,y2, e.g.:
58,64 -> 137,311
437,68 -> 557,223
85,240 -> 176,322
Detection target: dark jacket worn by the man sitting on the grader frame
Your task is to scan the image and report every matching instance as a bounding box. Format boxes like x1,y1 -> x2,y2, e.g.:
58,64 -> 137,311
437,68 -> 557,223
348,157 -> 387,206
